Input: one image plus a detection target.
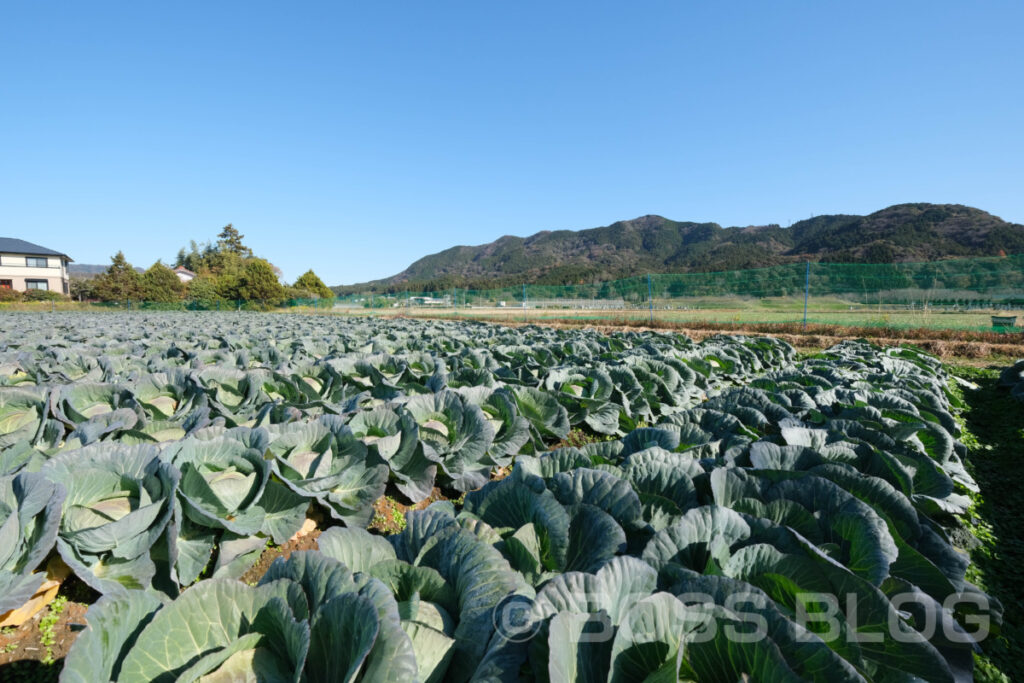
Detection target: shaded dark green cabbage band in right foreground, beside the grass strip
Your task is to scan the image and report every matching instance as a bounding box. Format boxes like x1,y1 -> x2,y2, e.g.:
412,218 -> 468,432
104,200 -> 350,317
34,331 -> 999,681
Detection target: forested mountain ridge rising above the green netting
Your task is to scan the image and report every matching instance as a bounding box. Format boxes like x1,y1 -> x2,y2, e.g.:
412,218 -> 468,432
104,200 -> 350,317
333,204 -> 1024,293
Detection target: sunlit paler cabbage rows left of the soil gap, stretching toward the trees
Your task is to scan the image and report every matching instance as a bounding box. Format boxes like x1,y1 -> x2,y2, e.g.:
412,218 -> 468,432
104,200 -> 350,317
0,314 -> 792,602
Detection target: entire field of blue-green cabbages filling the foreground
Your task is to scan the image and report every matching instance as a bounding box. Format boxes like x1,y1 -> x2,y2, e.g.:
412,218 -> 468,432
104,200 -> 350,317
0,313 -> 1000,683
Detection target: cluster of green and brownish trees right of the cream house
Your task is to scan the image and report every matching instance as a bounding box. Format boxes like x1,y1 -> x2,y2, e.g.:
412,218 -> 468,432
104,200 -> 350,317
71,223 -> 334,308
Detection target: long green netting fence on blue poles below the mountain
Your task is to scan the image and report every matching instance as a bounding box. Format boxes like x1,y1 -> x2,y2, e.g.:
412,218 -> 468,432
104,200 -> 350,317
323,255 -> 1024,332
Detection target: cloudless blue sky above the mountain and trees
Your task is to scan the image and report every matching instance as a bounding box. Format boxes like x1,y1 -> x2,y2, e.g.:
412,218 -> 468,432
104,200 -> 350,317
0,0 -> 1024,285
